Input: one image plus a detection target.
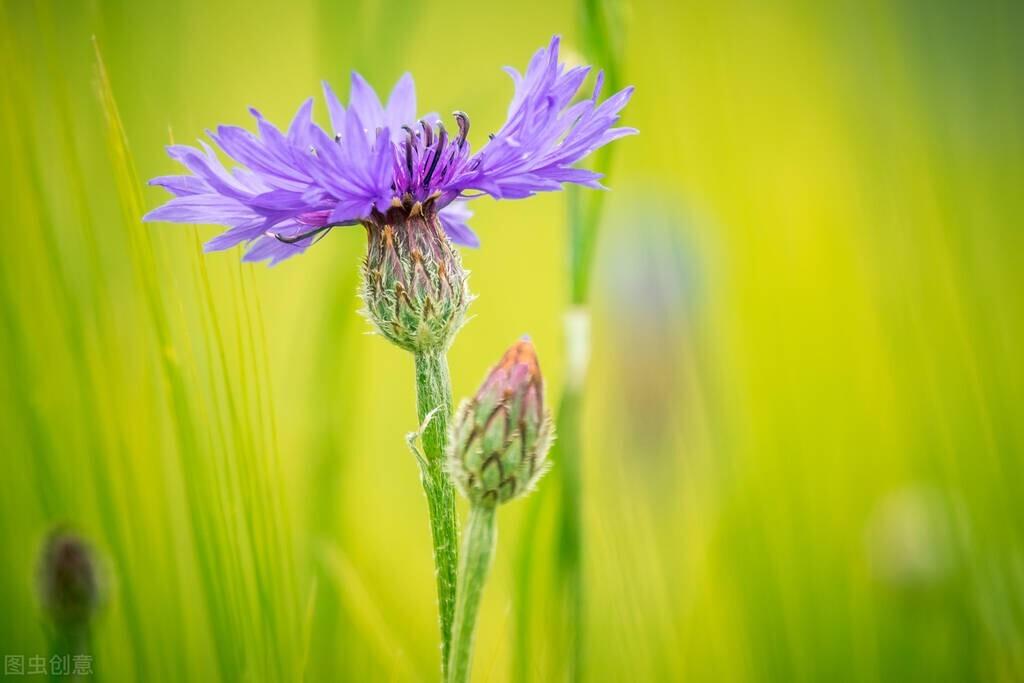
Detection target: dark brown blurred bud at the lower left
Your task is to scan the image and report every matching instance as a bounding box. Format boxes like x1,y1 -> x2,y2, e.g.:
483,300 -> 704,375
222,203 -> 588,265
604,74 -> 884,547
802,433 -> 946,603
39,529 -> 99,629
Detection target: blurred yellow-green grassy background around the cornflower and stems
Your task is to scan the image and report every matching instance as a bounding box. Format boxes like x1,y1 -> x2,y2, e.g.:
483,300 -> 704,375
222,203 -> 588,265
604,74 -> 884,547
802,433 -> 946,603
0,0 -> 1024,681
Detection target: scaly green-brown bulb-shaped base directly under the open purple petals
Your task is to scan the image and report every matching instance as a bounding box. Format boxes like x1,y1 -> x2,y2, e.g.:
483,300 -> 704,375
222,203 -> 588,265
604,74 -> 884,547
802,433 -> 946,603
361,204 -> 471,352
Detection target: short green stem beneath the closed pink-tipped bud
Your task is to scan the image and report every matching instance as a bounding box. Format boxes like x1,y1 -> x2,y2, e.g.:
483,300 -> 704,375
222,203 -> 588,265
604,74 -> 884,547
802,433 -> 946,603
447,505 -> 498,683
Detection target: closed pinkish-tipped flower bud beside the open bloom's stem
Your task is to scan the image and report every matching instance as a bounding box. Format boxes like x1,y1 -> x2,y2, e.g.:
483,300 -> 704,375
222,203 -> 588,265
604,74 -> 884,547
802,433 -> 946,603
449,338 -> 554,505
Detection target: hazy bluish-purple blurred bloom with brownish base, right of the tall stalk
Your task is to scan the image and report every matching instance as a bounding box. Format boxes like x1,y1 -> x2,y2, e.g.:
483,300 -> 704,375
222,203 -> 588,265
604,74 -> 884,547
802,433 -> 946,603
595,202 -> 703,464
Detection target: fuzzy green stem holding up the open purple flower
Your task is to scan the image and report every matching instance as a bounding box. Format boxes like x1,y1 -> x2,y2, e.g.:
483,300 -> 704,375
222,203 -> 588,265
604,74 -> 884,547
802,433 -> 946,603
416,351 -> 459,675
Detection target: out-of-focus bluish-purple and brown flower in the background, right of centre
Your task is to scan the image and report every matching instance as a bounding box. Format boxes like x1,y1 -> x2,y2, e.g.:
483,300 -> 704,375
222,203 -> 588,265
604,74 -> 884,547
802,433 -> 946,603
594,198 -> 715,466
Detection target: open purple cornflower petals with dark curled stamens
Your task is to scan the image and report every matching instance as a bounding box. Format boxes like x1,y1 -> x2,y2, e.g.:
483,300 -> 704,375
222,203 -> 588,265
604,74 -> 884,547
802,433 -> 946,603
144,36 -> 637,264
